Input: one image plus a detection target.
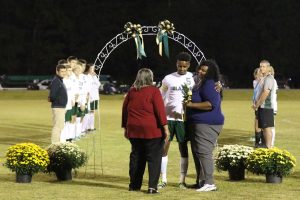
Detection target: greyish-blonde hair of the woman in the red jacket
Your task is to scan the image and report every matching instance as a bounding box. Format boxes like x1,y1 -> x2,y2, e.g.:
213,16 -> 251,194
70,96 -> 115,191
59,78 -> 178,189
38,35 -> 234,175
133,68 -> 153,90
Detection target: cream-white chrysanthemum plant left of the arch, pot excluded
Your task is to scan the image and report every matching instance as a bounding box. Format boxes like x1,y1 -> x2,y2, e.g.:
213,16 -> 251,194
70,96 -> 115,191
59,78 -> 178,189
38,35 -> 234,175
47,142 -> 87,172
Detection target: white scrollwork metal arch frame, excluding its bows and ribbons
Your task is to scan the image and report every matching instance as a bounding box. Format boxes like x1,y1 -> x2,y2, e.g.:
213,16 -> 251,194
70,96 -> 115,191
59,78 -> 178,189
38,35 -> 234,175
94,26 -> 206,77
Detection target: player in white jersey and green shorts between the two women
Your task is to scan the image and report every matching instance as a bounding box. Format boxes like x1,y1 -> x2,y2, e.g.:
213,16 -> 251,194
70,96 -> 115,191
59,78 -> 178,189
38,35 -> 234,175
158,52 -> 195,189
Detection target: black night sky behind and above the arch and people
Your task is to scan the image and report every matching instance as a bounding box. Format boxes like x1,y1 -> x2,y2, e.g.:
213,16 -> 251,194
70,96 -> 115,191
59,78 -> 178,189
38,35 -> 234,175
0,0 -> 300,87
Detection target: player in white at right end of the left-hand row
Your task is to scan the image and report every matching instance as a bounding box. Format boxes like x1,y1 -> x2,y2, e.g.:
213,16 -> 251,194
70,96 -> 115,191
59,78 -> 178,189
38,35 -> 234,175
85,64 -> 101,131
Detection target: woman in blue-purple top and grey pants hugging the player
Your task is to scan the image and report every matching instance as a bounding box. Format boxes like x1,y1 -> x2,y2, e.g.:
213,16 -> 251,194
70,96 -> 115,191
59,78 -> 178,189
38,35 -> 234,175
186,60 -> 224,192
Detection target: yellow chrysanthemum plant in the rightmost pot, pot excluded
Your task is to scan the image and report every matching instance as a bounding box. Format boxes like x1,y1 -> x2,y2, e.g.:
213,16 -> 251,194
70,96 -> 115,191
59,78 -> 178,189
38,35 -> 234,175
246,147 -> 296,177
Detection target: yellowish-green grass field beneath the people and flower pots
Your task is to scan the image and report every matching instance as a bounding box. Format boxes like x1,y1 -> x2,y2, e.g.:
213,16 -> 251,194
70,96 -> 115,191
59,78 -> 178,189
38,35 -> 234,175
0,90 -> 300,200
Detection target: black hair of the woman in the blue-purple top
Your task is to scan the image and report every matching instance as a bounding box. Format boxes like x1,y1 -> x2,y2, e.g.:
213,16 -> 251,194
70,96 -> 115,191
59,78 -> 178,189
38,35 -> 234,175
197,59 -> 220,82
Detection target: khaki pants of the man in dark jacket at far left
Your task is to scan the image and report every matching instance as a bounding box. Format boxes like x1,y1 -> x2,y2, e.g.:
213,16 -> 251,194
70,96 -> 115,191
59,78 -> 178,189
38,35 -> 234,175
51,108 -> 66,144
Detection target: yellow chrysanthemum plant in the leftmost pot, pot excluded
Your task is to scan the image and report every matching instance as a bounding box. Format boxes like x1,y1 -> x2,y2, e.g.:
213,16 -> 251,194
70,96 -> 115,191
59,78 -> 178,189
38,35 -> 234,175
4,143 -> 49,175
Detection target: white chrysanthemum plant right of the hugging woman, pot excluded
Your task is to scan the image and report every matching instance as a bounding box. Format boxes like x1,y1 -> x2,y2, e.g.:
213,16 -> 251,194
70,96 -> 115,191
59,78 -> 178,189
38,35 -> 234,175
216,144 -> 253,171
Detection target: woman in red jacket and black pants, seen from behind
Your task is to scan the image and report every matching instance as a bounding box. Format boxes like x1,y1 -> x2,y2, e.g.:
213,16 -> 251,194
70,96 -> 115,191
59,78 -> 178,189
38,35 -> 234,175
122,68 -> 169,194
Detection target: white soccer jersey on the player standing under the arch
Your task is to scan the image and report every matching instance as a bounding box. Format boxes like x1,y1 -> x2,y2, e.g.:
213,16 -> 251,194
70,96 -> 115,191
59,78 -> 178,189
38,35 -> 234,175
161,72 -> 195,121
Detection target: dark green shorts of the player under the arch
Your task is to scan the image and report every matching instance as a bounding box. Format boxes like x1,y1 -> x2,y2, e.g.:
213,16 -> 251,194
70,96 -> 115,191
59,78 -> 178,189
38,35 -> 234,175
168,120 -> 189,143
